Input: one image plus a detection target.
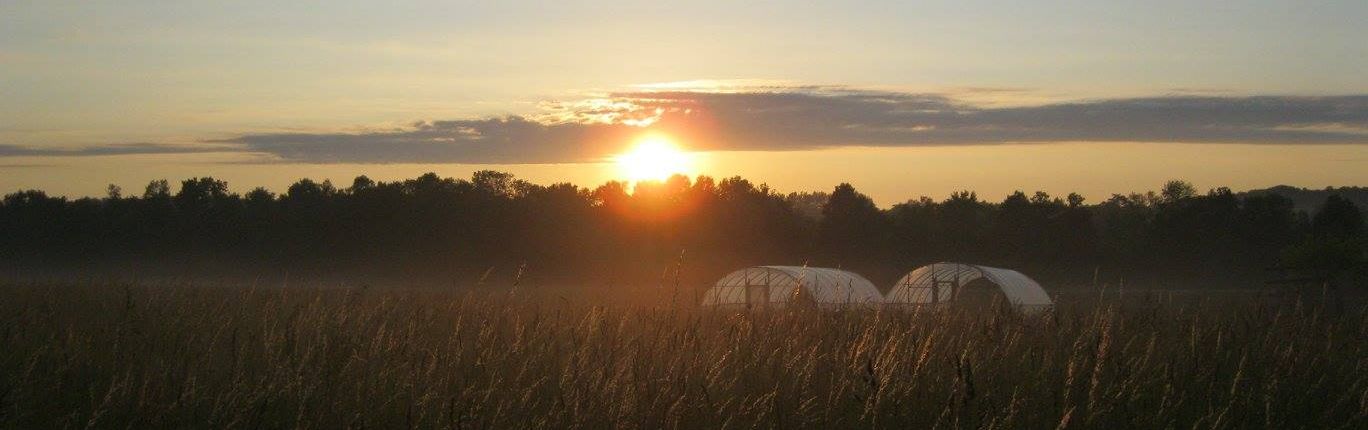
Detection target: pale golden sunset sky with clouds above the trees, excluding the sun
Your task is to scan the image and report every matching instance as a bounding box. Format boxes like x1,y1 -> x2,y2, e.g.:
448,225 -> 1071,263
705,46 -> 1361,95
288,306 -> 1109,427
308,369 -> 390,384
0,0 -> 1368,205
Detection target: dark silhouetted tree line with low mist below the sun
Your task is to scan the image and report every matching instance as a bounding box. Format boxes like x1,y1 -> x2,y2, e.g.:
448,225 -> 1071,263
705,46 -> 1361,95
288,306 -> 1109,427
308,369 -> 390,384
0,171 -> 1368,286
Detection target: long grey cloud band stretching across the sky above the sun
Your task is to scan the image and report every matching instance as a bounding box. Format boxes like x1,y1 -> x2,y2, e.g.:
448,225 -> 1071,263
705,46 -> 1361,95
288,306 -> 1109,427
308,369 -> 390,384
0,85 -> 1368,163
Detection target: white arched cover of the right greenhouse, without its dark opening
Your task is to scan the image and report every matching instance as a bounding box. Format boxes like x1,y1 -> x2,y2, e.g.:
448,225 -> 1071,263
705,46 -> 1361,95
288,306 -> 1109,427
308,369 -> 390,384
886,263 -> 1055,307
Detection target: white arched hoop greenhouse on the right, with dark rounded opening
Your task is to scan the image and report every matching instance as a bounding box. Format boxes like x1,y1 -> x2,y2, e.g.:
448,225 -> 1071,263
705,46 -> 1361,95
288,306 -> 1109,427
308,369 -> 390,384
884,263 -> 1055,312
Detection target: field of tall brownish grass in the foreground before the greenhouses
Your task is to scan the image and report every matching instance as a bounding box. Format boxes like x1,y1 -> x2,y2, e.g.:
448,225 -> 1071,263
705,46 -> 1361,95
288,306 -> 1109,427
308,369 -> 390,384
0,282 -> 1368,429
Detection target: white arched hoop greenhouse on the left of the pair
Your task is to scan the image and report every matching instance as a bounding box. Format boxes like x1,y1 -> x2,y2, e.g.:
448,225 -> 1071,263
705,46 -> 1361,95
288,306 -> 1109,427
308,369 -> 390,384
703,266 -> 884,308
